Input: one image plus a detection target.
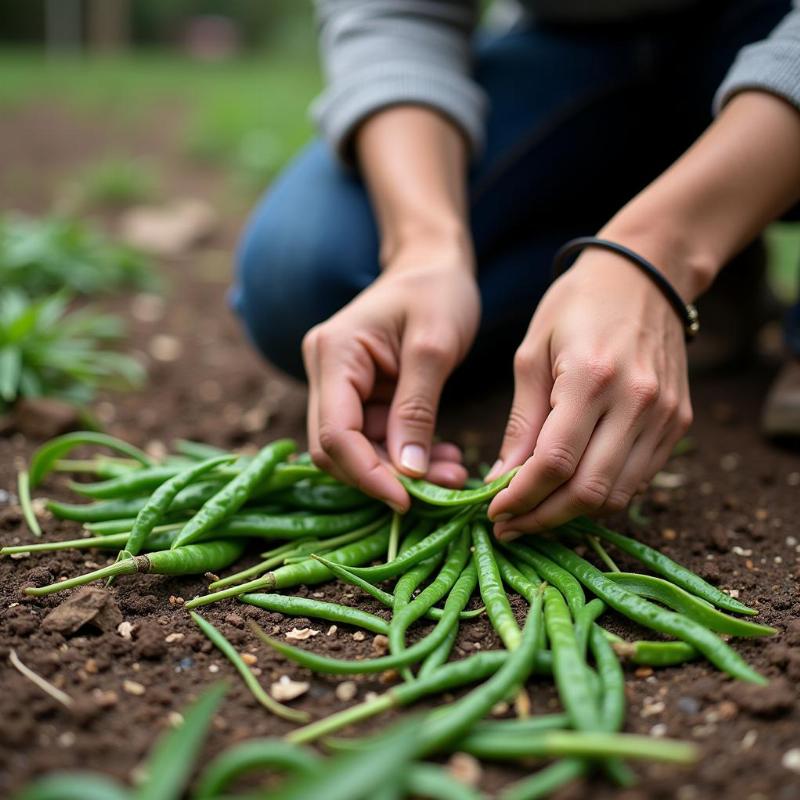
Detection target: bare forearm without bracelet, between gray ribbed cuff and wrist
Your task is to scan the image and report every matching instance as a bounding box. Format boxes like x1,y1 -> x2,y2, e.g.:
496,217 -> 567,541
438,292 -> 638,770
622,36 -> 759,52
355,106 -> 473,269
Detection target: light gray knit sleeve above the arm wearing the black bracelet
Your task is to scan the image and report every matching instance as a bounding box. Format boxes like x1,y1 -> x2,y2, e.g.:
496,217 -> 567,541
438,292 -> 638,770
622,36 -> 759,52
714,0 -> 800,112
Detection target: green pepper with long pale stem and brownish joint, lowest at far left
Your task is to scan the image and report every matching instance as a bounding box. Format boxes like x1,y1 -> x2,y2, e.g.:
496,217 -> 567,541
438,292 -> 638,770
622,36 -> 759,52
25,539 -> 244,597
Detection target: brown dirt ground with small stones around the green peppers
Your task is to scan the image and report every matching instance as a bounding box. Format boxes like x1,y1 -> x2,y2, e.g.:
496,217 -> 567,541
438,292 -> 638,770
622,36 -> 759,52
0,103 -> 800,800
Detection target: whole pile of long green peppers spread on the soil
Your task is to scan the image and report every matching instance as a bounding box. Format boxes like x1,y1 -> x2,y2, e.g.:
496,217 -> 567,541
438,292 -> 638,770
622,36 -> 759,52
9,434 -> 775,800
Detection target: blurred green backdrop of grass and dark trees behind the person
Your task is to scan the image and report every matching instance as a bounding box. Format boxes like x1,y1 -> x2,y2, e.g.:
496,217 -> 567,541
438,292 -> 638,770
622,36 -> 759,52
0,0 -> 800,300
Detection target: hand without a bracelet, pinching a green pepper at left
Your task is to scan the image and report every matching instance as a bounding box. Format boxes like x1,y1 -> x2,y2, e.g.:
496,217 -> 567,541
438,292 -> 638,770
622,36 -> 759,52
303,247 -> 480,512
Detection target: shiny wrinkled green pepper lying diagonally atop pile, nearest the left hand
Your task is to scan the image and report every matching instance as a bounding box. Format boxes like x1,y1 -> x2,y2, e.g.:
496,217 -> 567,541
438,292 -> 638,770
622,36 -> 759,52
172,439 -> 295,548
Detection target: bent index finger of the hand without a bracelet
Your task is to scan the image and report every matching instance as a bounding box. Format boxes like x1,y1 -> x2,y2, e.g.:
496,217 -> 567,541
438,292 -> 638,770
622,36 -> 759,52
318,341 -> 410,513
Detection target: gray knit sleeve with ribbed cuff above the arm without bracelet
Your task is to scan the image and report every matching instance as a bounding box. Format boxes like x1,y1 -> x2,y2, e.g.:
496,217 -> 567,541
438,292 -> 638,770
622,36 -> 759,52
311,0 -> 486,159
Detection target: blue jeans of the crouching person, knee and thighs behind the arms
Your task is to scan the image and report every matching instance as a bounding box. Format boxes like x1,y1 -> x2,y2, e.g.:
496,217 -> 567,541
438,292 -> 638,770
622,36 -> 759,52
233,0 -> 789,377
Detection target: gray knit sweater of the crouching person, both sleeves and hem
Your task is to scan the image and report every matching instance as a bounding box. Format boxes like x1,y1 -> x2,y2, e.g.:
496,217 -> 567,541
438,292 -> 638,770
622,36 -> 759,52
312,0 -> 800,158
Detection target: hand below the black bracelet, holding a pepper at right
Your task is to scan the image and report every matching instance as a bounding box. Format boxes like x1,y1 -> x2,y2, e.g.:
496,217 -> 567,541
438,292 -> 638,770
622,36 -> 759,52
487,248 -> 692,540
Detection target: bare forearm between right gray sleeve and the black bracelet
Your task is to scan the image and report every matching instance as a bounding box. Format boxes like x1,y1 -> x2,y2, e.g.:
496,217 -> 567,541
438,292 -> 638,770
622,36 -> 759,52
600,91 -> 800,301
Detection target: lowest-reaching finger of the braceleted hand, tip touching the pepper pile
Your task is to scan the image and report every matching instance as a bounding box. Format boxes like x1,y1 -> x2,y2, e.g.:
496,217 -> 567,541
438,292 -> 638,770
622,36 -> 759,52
495,409 -> 648,539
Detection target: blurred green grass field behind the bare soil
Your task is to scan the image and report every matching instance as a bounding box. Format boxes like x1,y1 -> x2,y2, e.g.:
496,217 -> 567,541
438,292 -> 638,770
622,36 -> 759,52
0,47 -> 800,302
